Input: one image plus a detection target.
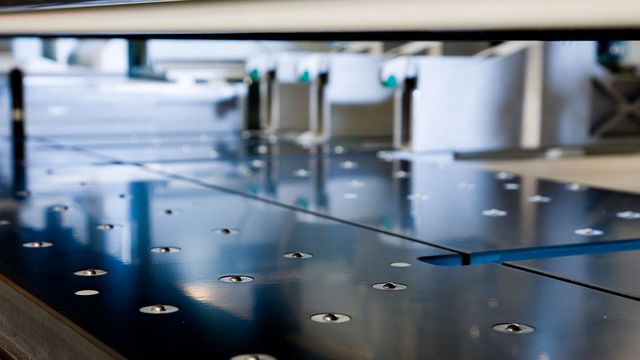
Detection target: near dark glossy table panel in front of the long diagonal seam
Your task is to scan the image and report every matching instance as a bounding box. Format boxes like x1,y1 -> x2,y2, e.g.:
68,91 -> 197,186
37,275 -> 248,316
6,144 -> 640,359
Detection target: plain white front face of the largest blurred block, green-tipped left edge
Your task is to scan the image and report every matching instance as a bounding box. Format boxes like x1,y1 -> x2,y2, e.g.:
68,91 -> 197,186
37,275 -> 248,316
381,51 -> 526,152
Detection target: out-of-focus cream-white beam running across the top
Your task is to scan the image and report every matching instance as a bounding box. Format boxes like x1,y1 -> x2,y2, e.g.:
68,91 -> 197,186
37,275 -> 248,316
0,0 -> 640,35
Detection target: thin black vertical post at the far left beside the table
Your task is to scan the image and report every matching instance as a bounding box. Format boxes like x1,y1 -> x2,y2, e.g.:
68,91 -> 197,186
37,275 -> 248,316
9,69 -> 26,197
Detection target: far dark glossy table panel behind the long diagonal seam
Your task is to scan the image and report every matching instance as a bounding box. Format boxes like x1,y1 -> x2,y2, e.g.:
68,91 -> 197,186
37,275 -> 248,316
48,136 -> 640,253
